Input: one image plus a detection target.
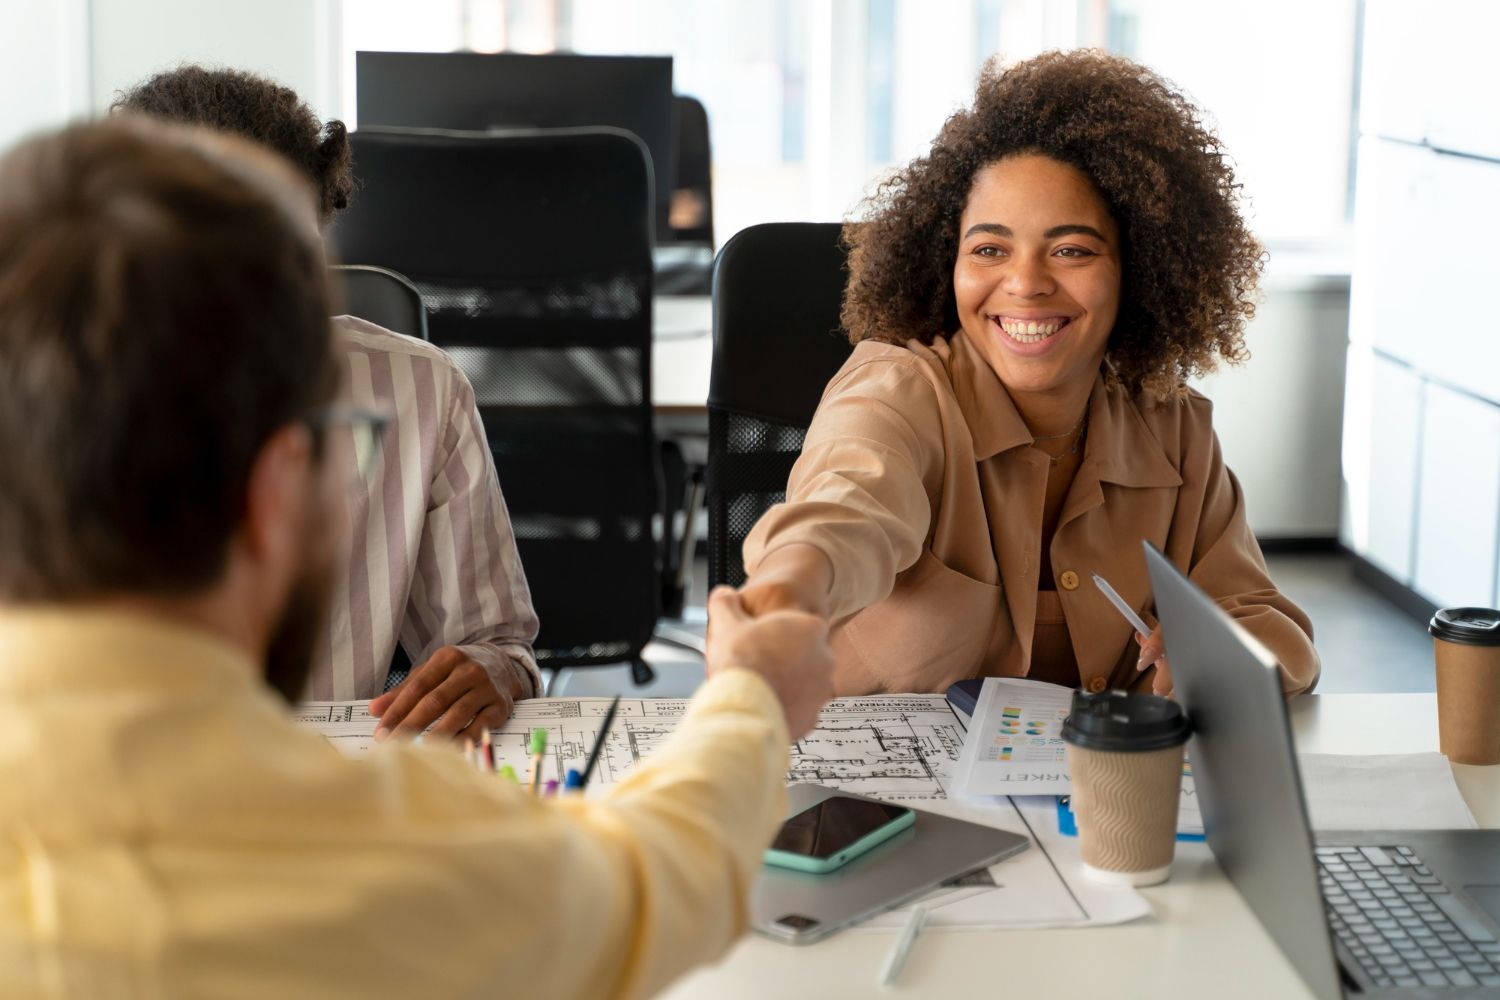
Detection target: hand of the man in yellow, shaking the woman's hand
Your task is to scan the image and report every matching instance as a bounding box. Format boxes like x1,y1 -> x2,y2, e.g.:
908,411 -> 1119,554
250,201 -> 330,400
705,586 -> 834,739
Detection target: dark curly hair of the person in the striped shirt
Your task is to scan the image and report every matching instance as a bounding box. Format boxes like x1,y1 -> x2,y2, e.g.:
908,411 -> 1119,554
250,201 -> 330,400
110,66 -> 354,223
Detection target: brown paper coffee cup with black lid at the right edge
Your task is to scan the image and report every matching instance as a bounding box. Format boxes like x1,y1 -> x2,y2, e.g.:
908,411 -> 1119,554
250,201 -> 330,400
1427,607 -> 1500,765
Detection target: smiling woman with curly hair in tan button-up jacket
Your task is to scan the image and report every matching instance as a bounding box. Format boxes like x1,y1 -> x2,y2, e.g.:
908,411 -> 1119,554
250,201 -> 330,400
743,51 -> 1319,704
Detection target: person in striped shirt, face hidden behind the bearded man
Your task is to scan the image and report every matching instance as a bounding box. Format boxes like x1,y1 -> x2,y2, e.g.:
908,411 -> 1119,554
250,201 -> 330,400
111,66 -> 542,738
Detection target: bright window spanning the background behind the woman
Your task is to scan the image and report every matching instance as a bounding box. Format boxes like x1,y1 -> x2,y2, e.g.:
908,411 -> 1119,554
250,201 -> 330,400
344,0 -> 1356,243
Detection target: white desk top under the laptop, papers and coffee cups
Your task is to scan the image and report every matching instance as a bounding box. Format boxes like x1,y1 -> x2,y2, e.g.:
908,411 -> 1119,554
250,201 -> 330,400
666,694 -> 1500,1000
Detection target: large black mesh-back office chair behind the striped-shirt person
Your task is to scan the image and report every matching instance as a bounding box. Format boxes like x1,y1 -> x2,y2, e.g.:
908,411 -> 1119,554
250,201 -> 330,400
333,129 -> 666,682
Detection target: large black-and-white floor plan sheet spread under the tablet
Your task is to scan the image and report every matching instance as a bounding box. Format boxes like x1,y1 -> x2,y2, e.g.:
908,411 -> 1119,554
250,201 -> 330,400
297,694 -> 1151,928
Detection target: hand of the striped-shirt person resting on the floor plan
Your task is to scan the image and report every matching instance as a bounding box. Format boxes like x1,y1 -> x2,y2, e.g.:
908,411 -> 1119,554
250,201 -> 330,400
371,646 -> 525,739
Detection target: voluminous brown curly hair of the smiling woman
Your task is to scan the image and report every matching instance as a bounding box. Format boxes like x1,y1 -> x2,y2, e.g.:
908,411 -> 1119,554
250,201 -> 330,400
843,51 -> 1265,399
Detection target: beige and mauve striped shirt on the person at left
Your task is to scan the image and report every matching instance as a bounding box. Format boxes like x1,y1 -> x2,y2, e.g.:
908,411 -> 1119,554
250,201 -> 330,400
306,316 -> 542,700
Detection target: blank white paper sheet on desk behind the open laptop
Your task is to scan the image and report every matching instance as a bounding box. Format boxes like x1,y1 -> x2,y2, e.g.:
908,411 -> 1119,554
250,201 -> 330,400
1298,753 -> 1478,831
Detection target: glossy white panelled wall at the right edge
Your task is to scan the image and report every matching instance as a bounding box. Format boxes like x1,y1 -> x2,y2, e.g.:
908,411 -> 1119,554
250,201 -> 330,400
1343,0 -> 1500,604
